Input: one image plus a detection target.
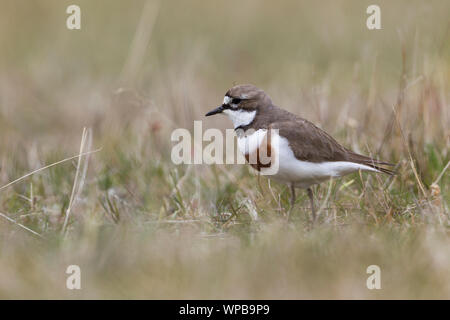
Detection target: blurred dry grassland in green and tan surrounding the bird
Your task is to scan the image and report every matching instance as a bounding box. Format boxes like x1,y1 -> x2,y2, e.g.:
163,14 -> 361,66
0,0 -> 450,299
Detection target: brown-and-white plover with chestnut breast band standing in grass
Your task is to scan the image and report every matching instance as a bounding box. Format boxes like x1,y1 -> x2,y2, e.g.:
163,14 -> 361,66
206,84 -> 394,222
